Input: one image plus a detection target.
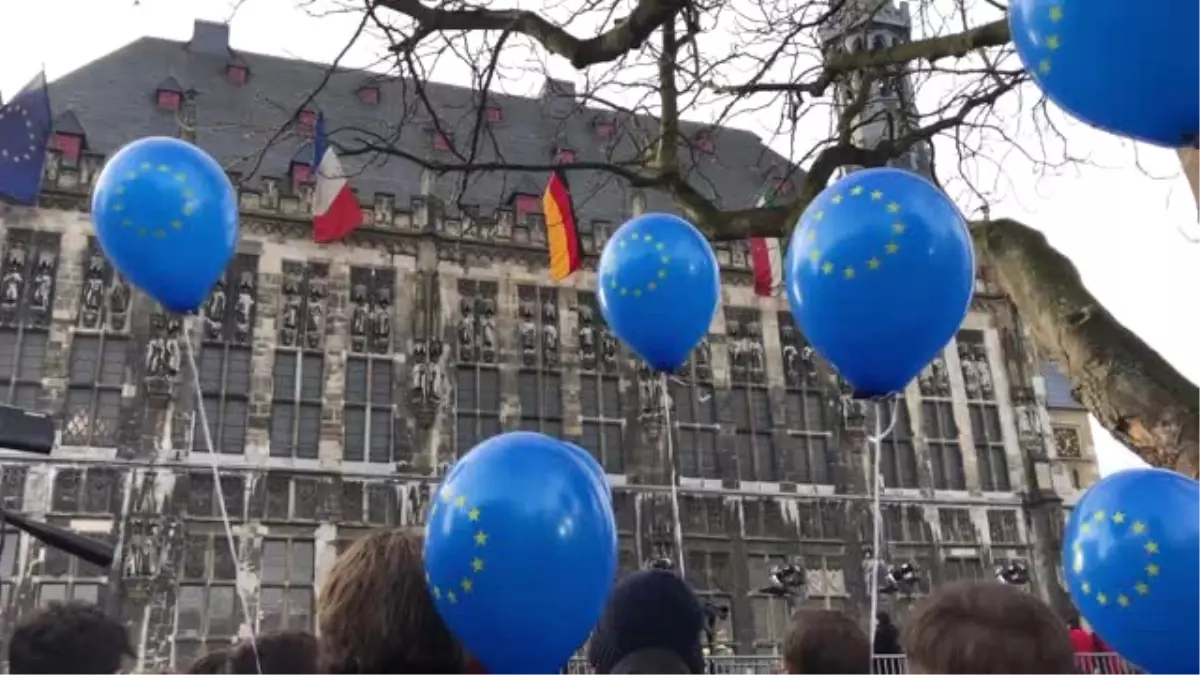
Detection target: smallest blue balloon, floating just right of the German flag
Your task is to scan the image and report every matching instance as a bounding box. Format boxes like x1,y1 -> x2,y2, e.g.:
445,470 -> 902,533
596,214 -> 721,372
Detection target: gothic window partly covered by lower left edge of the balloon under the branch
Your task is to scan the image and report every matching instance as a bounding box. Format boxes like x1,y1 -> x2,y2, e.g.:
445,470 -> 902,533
779,312 -> 834,484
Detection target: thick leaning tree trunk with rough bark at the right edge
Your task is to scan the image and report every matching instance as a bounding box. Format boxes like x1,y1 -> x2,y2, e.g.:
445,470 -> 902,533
972,220 -> 1200,477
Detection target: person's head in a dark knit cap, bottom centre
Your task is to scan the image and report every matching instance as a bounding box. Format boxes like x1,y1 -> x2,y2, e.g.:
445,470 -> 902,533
588,569 -> 704,675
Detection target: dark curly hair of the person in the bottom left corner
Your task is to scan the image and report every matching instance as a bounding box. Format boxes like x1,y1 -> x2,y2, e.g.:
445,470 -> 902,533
8,603 -> 134,675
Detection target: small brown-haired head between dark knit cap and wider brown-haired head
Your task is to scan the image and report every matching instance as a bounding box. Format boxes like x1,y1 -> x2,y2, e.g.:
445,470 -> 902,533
784,610 -> 873,675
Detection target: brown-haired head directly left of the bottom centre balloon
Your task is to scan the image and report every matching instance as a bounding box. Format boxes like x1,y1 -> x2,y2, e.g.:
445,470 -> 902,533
317,531 -> 463,675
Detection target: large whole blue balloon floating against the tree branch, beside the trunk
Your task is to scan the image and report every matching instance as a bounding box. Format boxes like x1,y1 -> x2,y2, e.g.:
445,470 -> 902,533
784,168 -> 974,398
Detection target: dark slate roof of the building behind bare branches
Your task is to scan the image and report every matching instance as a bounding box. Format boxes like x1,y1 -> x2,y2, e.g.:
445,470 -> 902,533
50,22 -> 787,222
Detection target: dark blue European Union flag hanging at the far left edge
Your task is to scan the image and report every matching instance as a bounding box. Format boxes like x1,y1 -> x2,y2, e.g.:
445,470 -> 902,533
0,72 -> 52,207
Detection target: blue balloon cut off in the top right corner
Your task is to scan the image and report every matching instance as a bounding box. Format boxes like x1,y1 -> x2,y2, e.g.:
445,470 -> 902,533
1008,0 -> 1200,148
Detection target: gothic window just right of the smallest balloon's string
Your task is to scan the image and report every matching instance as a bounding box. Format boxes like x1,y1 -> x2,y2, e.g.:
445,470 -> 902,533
672,339 -> 720,478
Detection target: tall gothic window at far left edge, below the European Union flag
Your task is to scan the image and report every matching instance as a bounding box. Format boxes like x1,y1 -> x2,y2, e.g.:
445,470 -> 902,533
0,229 -> 59,410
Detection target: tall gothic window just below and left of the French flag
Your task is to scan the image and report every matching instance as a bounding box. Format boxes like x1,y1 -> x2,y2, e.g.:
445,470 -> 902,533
271,261 -> 329,459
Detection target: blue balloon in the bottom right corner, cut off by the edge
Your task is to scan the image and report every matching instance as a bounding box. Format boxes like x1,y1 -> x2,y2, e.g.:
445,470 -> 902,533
1062,468 -> 1200,675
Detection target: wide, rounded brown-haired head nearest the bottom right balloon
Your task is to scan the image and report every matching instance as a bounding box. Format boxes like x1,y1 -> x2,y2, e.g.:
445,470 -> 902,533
901,581 -> 1075,675
